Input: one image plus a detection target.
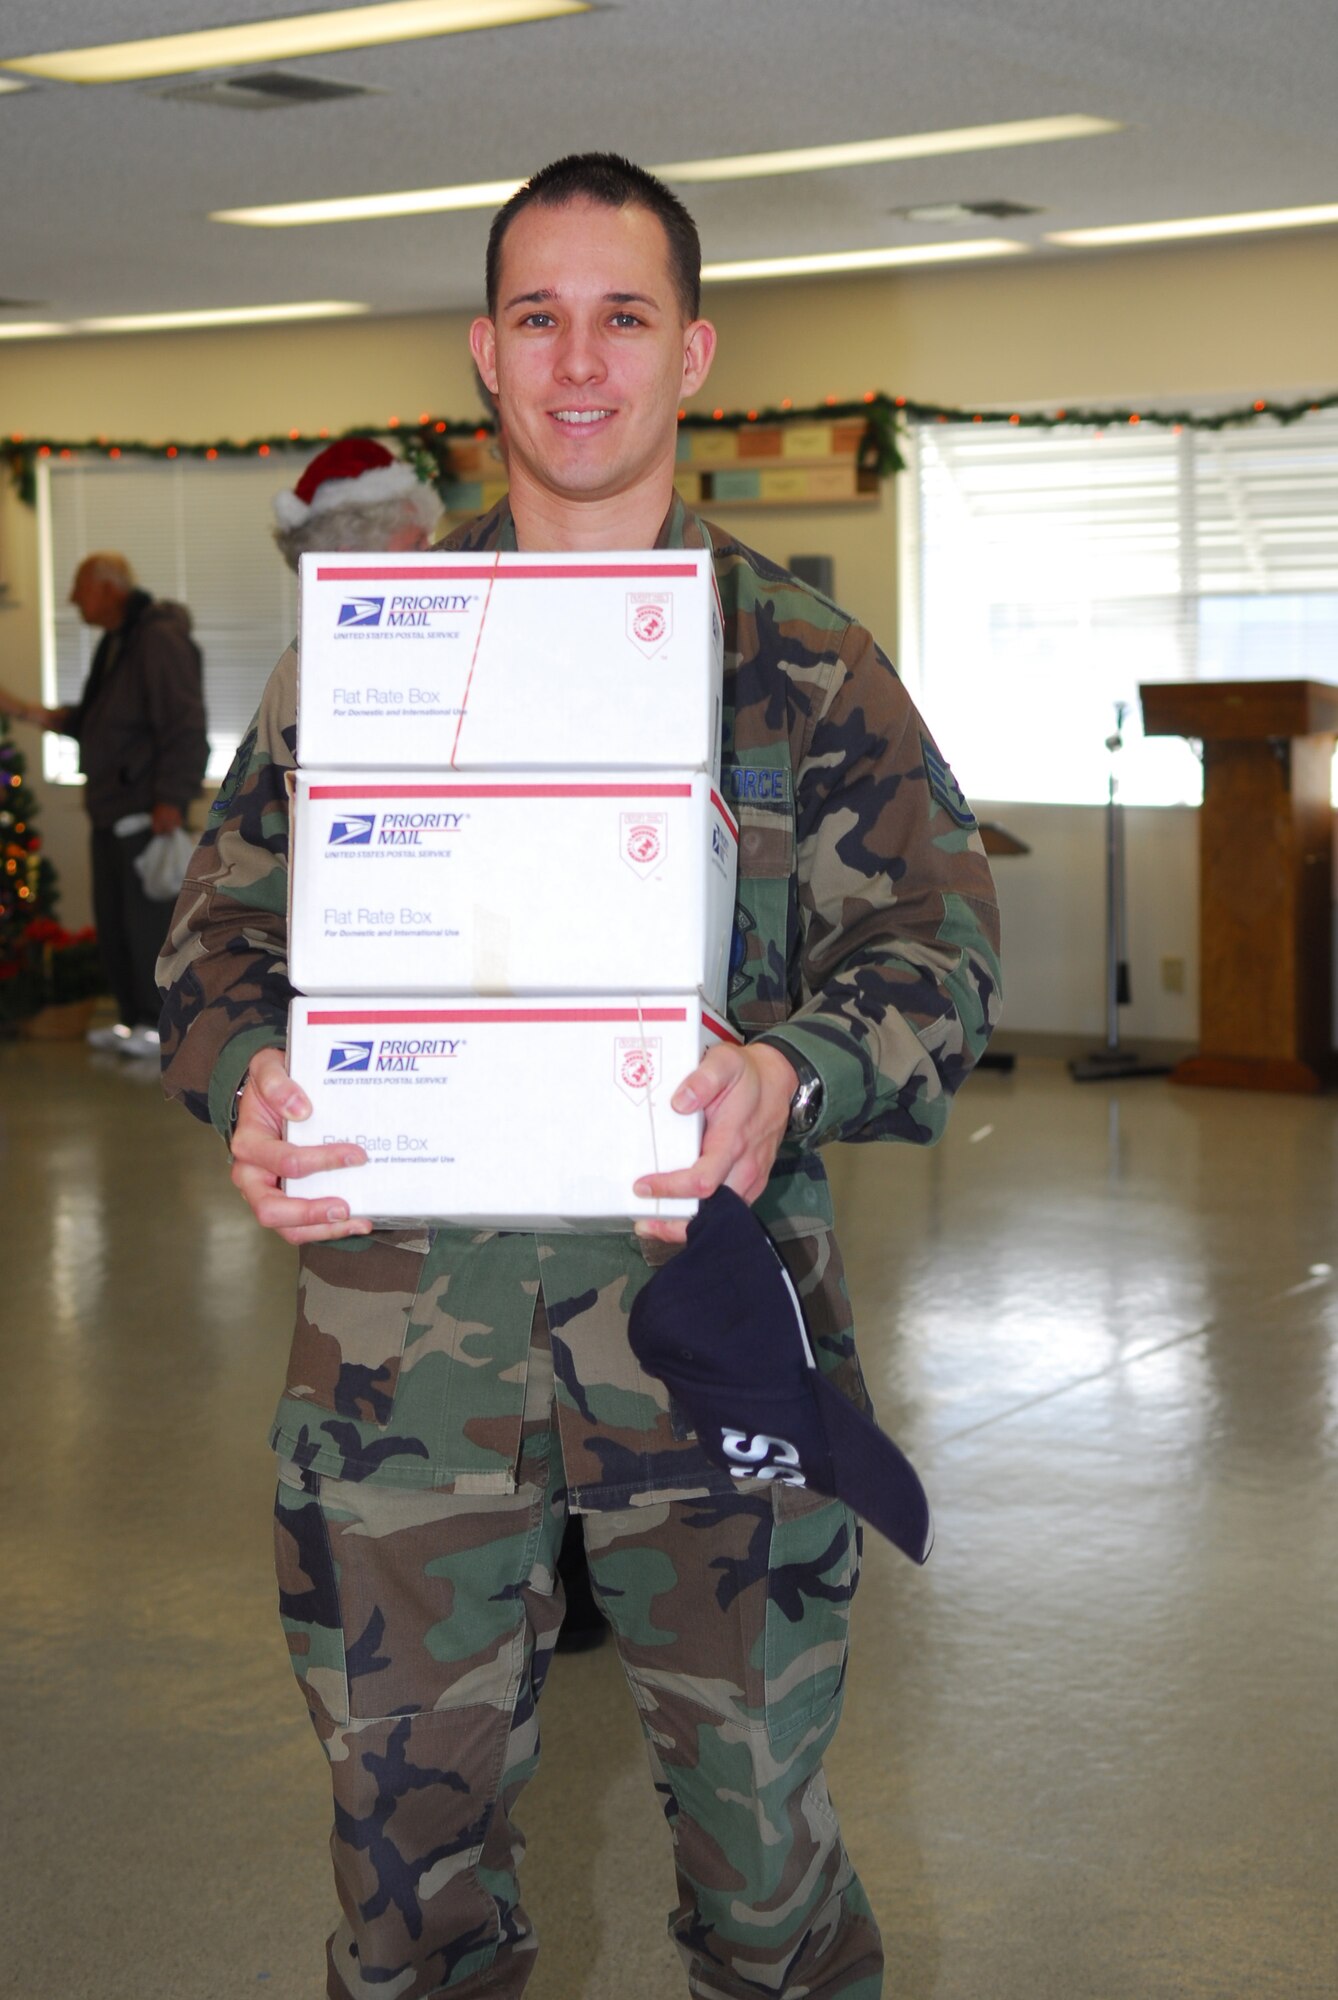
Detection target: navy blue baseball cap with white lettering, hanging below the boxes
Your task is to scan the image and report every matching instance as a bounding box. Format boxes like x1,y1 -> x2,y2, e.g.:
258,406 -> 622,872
628,1188 -> 934,1562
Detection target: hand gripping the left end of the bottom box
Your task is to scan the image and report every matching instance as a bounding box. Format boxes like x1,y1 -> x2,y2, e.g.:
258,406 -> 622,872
232,1048 -> 372,1244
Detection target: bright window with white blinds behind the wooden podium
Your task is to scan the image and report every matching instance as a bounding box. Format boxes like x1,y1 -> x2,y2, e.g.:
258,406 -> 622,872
902,412 -> 1338,806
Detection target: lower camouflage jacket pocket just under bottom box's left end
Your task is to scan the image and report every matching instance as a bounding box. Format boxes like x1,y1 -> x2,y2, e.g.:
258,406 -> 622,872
284,1230 -> 428,1430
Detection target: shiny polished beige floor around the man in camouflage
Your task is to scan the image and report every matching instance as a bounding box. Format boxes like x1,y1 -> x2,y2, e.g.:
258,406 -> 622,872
0,1042 -> 1338,2000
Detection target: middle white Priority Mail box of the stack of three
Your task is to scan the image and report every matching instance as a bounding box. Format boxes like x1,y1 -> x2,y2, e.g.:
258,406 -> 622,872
288,770 -> 738,1012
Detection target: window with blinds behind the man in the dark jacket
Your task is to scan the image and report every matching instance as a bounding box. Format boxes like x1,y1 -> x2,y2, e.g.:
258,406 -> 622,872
38,454 -> 304,784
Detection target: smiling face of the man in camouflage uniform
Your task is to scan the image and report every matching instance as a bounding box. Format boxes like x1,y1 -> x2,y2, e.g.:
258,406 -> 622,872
472,200 -> 714,506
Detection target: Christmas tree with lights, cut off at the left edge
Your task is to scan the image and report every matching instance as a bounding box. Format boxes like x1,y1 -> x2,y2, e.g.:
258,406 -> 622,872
0,716 -> 106,1028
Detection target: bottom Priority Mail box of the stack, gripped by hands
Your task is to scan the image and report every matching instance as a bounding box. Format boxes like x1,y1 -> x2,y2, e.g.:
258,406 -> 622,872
286,994 -> 738,1230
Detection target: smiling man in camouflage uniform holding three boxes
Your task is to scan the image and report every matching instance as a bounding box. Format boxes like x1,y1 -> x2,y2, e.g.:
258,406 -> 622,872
162,154 -> 998,2000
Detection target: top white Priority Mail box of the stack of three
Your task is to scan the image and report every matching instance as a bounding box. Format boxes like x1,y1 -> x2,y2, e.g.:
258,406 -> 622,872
298,550 -> 724,782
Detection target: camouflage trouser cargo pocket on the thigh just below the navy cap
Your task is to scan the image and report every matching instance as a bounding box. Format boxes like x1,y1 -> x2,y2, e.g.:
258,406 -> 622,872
764,1486 -> 860,1742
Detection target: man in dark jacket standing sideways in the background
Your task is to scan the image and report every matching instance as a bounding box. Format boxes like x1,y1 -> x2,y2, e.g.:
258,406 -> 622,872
16,554 -> 208,1058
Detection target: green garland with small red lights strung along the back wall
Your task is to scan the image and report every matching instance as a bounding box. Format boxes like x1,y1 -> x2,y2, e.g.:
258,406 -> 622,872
0,390 -> 1338,506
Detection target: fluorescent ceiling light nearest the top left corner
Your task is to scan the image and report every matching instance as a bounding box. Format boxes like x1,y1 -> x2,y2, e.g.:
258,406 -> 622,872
0,0 -> 590,84
